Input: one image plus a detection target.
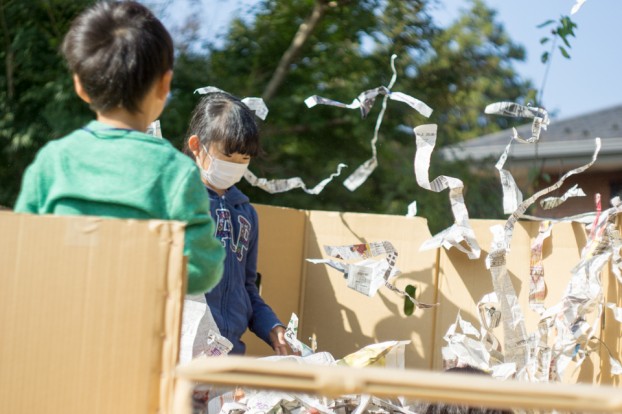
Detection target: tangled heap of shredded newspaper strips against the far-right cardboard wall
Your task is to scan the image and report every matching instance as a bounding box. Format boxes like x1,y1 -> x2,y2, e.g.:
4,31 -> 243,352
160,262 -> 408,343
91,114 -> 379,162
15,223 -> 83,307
442,197 -> 622,382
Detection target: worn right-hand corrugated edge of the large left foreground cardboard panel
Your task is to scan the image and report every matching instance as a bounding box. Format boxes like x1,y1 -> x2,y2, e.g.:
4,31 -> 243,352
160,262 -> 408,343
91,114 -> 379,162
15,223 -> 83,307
156,221 -> 187,413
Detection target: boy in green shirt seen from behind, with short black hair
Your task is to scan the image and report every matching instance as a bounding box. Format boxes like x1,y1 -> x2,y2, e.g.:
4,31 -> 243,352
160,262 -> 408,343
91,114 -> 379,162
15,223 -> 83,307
15,1 -> 225,293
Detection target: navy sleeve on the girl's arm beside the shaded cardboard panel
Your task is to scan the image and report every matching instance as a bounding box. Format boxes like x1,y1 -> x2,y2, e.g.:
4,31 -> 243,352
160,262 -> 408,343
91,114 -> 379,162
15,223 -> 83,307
245,209 -> 283,346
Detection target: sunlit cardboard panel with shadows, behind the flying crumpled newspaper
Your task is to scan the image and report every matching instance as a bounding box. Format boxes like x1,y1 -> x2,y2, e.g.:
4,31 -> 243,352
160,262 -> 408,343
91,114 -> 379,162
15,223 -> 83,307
299,211 -> 437,368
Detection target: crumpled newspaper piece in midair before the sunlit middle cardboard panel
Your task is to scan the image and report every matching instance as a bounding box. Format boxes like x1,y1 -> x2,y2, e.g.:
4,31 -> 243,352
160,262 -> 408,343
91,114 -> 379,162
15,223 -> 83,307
307,241 -> 436,309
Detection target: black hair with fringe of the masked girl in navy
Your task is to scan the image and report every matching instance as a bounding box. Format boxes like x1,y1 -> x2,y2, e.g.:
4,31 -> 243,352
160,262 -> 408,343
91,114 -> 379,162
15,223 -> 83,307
184,92 -> 261,157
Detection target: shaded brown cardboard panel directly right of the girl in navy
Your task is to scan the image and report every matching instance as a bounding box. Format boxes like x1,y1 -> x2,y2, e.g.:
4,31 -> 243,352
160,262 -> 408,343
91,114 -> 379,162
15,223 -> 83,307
242,204 -> 307,356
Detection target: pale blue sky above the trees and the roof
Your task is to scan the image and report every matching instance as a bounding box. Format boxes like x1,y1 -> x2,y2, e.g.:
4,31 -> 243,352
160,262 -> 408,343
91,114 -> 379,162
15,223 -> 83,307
163,0 -> 622,119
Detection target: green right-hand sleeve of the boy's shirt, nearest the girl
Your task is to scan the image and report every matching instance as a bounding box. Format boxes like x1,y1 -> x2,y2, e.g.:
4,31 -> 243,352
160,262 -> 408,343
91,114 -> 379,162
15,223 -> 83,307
171,170 -> 225,293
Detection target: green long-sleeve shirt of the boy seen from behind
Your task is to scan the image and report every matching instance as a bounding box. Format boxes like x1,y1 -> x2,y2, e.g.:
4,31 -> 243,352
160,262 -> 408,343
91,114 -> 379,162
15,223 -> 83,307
15,121 -> 225,293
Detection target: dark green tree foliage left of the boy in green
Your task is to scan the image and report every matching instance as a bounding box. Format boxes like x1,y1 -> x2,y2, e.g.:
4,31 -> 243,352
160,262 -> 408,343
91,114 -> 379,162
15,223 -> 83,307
0,0 -> 90,206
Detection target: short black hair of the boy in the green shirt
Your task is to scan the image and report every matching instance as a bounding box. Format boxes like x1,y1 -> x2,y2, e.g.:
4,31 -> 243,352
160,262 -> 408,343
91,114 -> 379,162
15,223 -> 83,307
62,1 -> 174,113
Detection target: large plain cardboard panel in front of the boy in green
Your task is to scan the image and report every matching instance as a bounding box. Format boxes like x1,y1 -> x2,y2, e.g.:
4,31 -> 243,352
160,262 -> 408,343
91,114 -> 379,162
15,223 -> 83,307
0,213 -> 185,414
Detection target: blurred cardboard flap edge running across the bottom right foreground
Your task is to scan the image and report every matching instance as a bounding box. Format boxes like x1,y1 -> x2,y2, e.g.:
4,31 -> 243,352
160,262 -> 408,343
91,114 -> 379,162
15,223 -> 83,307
174,357 -> 622,414
